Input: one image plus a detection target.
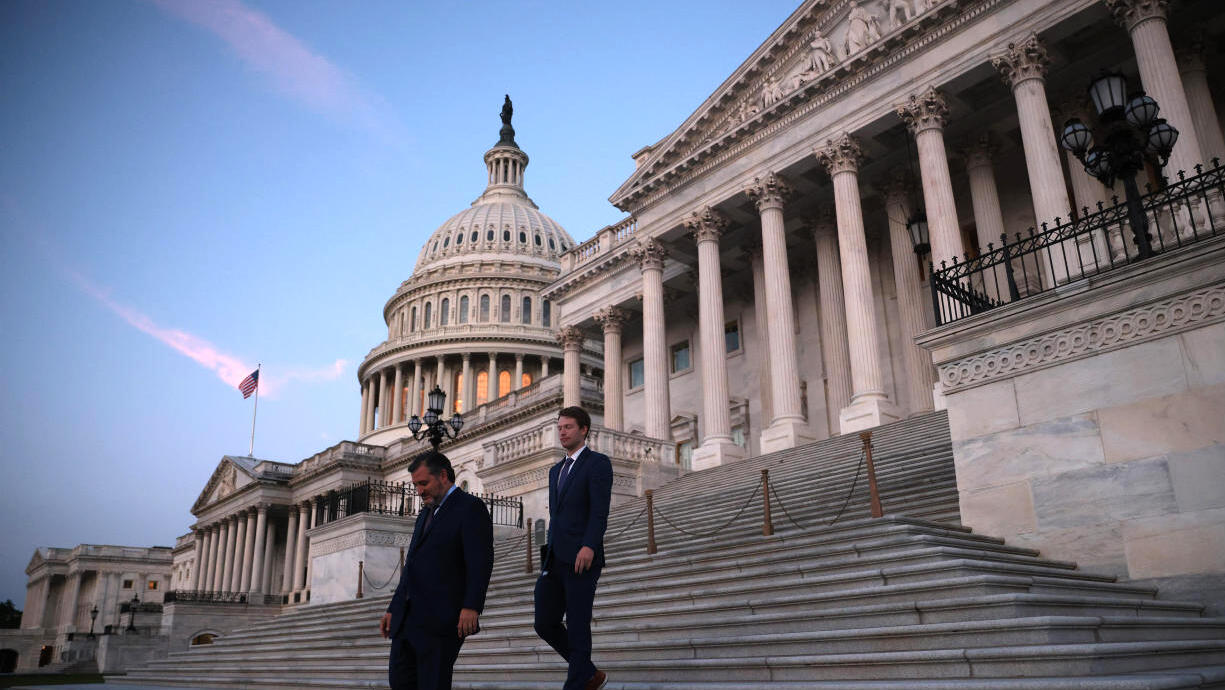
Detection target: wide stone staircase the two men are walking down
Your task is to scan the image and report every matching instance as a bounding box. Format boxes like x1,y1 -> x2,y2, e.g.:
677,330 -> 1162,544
116,413 -> 1225,690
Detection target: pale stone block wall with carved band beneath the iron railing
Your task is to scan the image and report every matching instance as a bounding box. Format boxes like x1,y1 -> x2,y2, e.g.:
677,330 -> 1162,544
919,238 -> 1225,612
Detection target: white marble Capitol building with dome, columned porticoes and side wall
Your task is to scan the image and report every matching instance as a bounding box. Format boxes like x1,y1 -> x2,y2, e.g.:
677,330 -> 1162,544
4,0 -> 1225,681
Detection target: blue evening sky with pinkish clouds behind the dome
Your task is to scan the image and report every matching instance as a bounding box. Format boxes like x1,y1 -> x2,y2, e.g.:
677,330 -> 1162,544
0,0 -> 796,607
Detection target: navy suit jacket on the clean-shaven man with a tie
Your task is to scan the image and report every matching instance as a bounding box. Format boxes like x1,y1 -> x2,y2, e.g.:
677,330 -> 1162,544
549,449 -> 613,567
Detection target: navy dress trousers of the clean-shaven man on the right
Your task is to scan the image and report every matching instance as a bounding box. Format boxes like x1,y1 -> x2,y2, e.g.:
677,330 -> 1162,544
535,559 -> 600,690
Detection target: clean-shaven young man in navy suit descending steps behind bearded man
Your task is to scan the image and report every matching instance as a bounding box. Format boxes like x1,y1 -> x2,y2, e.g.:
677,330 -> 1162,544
535,407 -> 613,690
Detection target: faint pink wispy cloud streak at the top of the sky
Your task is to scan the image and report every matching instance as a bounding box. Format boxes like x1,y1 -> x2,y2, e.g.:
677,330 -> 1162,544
152,0 -> 402,143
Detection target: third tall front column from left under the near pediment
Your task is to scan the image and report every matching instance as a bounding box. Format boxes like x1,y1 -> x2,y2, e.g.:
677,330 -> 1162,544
745,173 -> 816,453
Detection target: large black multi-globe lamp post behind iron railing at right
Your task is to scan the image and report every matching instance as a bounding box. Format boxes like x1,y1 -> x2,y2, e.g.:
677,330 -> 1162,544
1060,72 -> 1178,259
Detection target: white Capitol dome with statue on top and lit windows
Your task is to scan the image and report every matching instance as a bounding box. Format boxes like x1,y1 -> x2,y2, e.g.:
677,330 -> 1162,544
358,98 -> 598,444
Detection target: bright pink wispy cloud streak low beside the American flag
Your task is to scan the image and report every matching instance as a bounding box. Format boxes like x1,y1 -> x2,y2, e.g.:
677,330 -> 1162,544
64,267 -> 348,398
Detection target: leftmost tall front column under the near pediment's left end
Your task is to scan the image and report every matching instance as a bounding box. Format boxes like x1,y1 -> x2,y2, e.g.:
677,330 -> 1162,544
630,238 -> 673,441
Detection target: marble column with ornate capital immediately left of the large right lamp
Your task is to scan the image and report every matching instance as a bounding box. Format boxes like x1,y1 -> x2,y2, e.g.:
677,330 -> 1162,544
991,33 -> 1076,287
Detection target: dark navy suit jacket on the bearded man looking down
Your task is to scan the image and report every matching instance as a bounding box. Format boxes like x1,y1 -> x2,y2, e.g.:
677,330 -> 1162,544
387,488 -> 494,637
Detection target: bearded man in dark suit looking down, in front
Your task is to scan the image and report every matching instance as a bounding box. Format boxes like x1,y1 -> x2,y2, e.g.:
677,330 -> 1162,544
379,451 -> 494,690
